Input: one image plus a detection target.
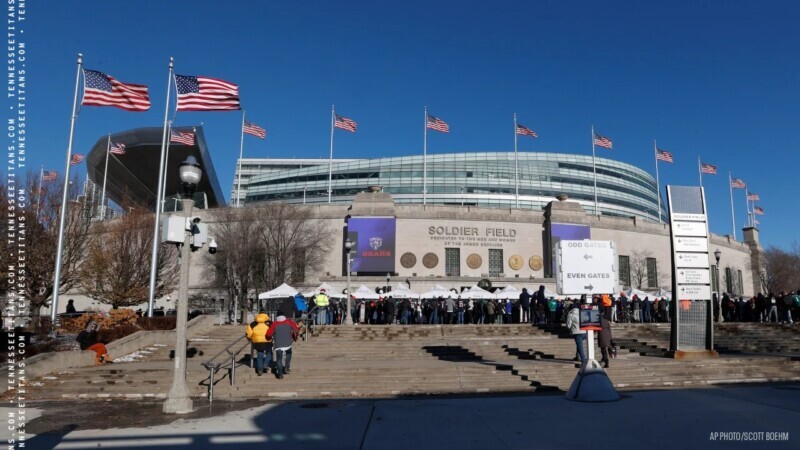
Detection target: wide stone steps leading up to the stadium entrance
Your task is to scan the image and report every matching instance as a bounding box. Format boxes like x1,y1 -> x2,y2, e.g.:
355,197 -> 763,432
14,324 -> 800,400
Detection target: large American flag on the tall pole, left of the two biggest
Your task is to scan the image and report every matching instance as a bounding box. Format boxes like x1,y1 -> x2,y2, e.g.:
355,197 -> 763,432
81,69 -> 150,111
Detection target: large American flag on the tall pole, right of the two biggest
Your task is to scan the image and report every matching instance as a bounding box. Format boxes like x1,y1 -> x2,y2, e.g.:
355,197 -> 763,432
175,75 -> 239,111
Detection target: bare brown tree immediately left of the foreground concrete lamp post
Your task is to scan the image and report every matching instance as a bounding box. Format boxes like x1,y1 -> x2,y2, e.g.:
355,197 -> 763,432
80,208 -> 178,308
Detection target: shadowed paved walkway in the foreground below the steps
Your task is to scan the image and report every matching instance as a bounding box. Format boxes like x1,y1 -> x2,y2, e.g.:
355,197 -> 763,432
7,384 -> 800,450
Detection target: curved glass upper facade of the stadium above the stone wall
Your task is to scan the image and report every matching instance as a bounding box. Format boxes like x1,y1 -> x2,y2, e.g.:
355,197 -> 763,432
242,152 -> 667,221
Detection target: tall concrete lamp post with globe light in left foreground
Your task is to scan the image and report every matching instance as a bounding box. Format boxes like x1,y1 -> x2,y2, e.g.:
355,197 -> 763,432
163,156 -> 203,414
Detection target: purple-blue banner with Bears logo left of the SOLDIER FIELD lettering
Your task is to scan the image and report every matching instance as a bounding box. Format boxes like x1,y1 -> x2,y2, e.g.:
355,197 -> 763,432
347,217 -> 396,274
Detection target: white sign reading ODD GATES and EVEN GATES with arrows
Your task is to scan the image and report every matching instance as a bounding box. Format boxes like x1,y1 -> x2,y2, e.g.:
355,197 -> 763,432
555,240 -> 617,295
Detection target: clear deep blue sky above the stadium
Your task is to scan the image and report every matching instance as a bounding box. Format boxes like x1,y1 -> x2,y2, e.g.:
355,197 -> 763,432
17,0 -> 800,247
